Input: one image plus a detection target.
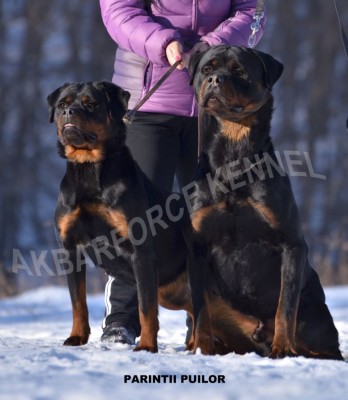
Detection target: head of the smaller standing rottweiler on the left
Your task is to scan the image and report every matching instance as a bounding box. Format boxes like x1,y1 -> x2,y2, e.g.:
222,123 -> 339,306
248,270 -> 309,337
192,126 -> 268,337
47,82 -> 130,163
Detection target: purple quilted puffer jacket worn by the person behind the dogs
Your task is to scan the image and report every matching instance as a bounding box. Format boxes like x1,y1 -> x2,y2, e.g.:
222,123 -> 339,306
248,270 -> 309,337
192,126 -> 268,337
100,0 -> 265,116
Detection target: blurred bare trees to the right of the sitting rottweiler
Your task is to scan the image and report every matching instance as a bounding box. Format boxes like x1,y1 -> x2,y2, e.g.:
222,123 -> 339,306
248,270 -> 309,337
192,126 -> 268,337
262,0 -> 348,284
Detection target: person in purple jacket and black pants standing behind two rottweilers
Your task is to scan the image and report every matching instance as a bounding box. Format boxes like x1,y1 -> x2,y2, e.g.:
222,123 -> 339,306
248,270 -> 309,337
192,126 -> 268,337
100,0 -> 265,344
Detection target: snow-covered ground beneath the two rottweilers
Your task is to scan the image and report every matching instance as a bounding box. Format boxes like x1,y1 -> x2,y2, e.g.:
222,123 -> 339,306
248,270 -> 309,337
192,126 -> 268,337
0,287 -> 348,400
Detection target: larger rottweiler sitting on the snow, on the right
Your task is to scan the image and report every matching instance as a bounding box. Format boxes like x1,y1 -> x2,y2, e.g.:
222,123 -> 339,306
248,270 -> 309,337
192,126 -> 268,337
189,45 -> 342,360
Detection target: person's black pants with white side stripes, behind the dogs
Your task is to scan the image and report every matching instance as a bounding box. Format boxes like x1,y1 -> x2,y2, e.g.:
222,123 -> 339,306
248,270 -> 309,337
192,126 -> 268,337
103,112 -> 197,336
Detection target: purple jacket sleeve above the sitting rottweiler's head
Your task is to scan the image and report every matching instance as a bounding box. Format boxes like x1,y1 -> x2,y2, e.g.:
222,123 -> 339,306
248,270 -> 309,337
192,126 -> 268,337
201,0 -> 266,46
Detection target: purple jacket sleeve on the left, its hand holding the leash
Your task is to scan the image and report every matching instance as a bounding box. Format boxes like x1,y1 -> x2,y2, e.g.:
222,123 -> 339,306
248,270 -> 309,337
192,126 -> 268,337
100,0 -> 180,65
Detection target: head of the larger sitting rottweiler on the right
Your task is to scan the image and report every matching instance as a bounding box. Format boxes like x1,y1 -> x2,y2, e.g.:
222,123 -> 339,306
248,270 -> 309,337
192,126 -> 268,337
189,45 -> 283,122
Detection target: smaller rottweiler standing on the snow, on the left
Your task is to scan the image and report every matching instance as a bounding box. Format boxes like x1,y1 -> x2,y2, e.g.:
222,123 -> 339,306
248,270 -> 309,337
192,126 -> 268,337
47,82 -> 213,353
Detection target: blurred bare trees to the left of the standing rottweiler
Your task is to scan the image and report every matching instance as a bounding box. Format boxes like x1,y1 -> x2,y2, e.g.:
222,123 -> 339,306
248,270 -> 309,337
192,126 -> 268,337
0,0 -> 114,295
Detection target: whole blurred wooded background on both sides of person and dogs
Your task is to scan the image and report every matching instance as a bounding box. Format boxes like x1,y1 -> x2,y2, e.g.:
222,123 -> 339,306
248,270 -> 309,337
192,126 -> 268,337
0,0 -> 348,297
